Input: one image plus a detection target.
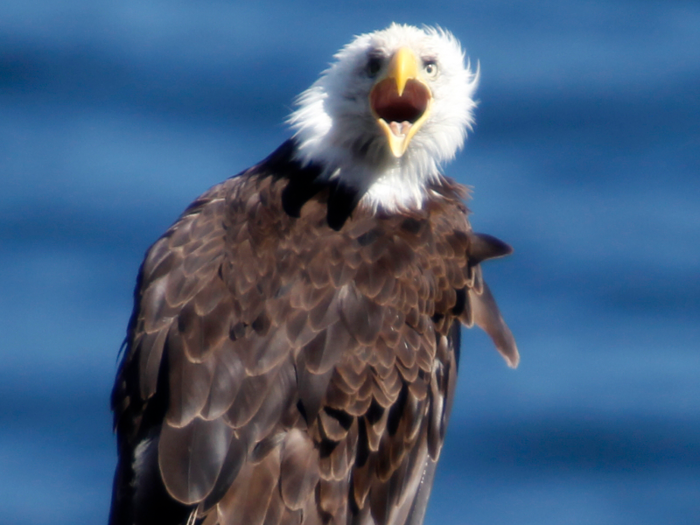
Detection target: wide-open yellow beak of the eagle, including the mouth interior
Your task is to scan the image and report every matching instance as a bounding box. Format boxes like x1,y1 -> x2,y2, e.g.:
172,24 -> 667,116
369,47 -> 433,158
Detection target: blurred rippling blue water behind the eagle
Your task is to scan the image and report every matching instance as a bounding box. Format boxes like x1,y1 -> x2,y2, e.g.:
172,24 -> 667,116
0,0 -> 700,525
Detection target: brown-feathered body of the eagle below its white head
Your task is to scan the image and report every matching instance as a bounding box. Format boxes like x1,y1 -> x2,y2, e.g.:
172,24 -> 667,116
110,142 -> 517,525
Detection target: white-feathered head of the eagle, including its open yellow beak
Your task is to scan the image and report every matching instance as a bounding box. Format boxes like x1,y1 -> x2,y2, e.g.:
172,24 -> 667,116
290,24 -> 478,210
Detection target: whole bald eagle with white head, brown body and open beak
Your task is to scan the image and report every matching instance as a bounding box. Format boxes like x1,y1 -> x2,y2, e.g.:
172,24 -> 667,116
110,24 -> 518,525
